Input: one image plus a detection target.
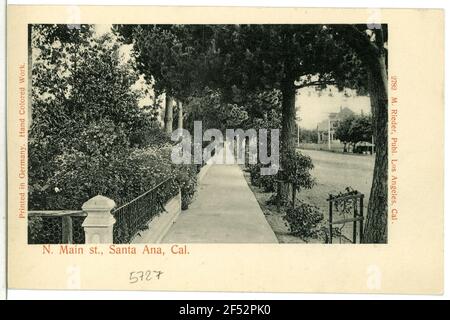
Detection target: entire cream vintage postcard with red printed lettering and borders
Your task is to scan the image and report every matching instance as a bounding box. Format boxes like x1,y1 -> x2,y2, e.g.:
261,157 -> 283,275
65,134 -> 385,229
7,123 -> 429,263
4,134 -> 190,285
7,6 -> 444,294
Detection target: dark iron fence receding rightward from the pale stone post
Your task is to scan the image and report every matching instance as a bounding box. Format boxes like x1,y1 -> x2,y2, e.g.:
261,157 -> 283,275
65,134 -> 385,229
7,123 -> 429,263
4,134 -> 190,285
111,178 -> 178,243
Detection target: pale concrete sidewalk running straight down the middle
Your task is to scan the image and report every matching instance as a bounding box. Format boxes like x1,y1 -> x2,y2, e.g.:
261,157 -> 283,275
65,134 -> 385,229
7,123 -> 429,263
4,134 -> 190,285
162,165 -> 278,243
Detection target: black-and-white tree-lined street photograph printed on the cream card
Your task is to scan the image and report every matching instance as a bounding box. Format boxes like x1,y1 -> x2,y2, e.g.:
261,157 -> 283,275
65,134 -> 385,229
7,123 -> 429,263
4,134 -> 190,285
23,24 -> 386,244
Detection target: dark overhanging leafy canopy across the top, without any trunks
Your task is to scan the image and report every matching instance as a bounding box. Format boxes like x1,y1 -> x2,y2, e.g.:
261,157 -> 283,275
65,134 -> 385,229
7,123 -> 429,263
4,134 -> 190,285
114,24 -> 365,94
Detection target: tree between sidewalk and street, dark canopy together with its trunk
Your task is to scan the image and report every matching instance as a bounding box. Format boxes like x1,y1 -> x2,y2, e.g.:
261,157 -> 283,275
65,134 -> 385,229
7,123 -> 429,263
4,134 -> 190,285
208,25 -> 366,197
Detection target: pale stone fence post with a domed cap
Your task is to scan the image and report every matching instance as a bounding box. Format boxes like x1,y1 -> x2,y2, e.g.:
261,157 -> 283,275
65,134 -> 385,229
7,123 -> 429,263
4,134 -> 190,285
81,195 -> 116,243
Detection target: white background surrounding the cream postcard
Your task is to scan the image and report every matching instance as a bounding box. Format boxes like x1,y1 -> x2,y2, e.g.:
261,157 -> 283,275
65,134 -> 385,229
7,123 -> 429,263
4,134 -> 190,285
0,0 -> 450,300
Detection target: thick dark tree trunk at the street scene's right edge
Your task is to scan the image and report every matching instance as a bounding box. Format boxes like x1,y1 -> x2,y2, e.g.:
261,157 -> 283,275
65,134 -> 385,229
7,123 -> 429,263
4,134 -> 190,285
363,54 -> 388,243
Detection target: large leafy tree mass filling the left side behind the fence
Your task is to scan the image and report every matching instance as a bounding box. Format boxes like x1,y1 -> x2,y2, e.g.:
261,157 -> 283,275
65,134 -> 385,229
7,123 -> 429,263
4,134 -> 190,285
29,26 -> 154,210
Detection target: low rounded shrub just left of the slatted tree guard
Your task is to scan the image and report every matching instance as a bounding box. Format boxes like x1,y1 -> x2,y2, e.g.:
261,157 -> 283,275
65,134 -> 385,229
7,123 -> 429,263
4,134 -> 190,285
284,202 -> 323,241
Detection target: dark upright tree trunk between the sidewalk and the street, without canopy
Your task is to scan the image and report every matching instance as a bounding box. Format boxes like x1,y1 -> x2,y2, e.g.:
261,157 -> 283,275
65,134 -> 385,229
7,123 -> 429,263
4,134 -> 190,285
278,79 -> 296,200
